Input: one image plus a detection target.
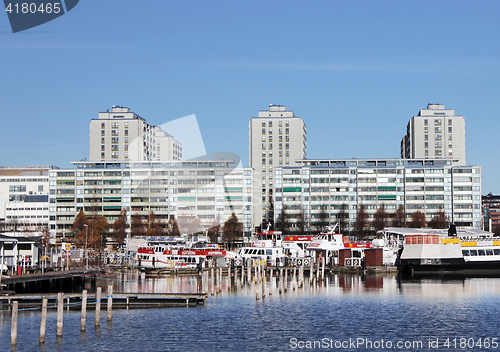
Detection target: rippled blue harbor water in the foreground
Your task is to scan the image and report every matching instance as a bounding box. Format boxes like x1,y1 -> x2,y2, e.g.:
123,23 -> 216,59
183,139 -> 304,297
0,274 -> 500,351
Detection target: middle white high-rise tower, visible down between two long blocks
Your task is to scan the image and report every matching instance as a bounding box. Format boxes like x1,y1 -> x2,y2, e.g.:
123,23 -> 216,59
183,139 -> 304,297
249,105 -> 307,230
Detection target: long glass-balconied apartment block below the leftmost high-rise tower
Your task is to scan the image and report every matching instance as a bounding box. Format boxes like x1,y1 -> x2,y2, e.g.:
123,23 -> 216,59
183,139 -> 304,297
49,160 -> 252,239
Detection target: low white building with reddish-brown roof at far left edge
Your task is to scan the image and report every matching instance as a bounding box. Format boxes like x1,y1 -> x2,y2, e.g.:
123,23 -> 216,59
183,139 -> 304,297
0,166 -> 58,236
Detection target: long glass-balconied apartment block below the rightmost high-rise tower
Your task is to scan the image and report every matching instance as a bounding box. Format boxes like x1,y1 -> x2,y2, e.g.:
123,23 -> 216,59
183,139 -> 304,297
275,159 -> 481,231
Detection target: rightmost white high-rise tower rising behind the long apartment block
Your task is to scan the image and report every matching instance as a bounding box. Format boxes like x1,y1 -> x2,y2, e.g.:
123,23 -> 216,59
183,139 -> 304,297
401,104 -> 465,165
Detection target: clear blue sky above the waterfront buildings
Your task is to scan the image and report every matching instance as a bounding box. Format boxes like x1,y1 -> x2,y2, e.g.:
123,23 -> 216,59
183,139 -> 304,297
0,0 -> 500,194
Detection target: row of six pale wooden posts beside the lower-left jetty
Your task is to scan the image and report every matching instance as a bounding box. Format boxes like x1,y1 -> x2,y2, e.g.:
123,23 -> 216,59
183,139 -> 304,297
11,285 -> 113,345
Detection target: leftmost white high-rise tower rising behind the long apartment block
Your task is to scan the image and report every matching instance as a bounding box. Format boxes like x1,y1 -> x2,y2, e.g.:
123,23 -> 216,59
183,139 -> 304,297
89,106 -> 182,161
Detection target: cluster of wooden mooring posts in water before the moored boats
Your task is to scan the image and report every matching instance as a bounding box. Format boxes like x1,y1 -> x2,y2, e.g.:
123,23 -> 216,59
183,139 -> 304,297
210,260 -> 325,300
